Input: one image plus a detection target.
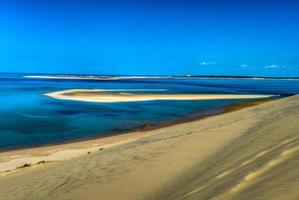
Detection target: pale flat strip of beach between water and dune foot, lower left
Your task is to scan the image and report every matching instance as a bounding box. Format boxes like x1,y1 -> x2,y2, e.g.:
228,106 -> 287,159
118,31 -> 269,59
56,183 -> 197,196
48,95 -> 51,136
0,136 -> 142,176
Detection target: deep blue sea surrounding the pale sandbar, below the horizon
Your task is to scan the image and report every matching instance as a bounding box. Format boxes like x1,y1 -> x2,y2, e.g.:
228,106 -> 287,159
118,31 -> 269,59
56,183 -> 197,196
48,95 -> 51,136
0,74 -> 299,150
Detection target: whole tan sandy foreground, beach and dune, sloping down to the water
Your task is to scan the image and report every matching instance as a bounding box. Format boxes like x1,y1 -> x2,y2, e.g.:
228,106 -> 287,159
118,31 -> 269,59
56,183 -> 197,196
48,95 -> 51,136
0,95 -> 299,200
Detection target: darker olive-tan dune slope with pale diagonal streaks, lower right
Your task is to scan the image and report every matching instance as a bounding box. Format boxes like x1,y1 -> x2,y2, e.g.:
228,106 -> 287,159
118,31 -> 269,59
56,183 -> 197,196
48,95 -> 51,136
157,96 -> 299,200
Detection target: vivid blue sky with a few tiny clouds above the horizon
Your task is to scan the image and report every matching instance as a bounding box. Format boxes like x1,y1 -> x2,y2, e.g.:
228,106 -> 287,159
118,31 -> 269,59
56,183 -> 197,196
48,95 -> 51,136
0,0 -> 299,76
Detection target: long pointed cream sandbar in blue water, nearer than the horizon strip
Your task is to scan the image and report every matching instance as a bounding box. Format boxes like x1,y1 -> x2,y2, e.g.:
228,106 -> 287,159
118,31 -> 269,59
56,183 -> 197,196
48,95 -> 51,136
44,89 -> 273,103
